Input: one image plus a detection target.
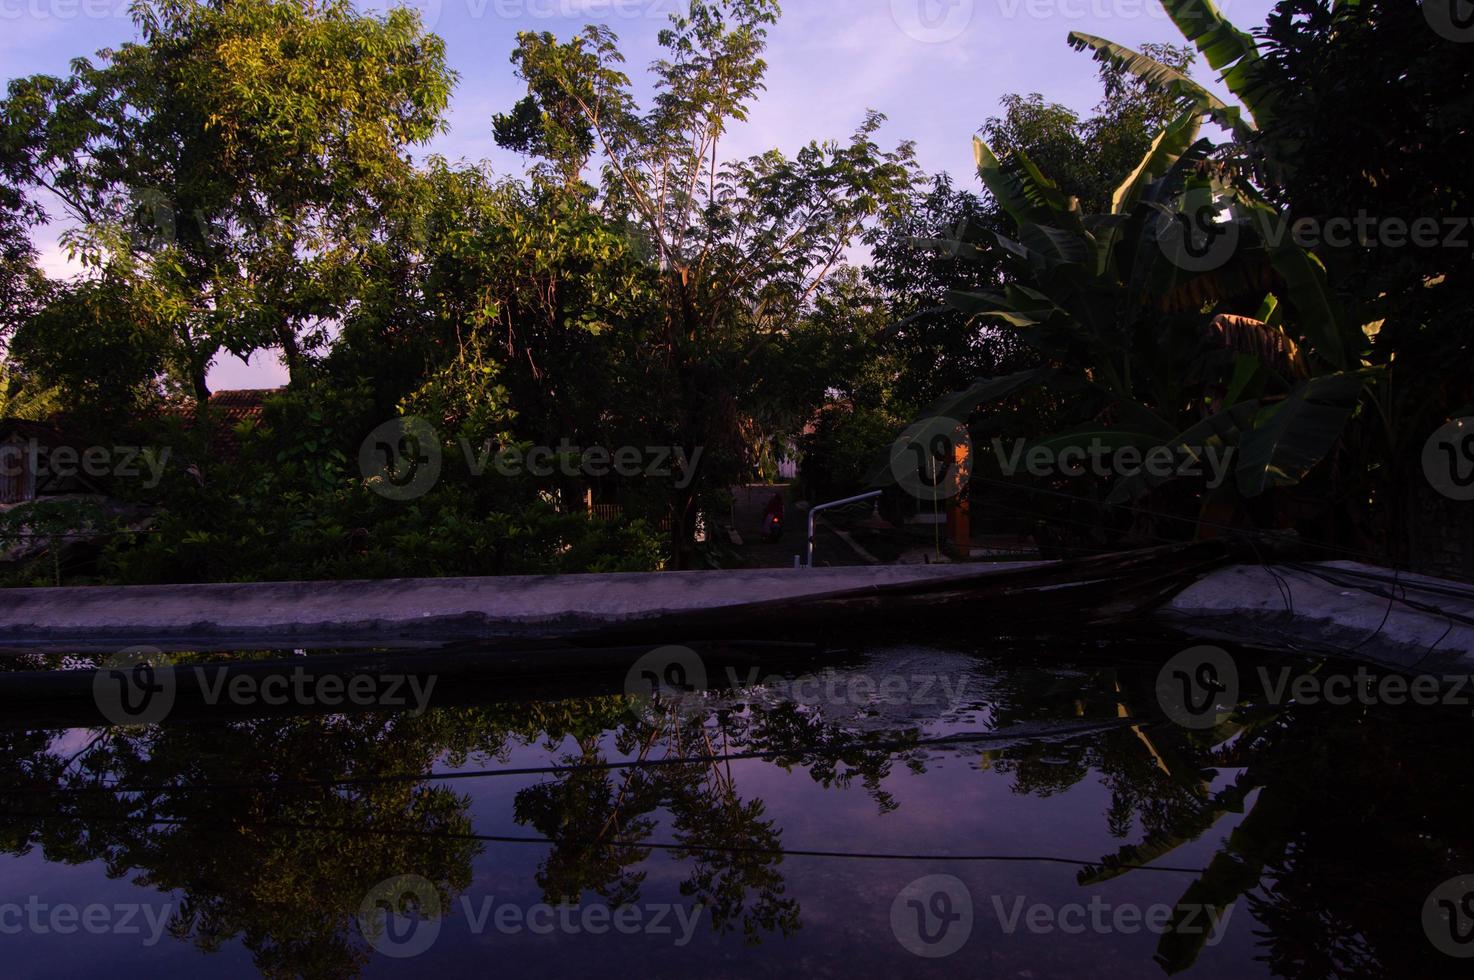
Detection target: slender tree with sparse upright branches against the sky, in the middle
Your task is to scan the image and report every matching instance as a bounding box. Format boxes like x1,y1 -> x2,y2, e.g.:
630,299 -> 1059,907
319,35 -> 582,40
495,0 -> 912,567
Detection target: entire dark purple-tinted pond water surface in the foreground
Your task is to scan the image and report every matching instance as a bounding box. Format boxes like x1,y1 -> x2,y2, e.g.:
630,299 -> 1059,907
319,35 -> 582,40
0,641 -> 1474,980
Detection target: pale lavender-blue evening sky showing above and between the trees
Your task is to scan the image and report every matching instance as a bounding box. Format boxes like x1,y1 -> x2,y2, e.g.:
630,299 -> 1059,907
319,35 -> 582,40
0,0 -> 1272,391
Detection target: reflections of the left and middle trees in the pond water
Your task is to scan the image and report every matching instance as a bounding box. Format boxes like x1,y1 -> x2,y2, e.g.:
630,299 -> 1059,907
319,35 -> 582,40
0,686 -> 907,976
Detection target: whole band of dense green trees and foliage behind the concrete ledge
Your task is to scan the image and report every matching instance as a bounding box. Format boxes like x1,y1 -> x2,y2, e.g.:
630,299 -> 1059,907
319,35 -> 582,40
0,0 -> 1474,581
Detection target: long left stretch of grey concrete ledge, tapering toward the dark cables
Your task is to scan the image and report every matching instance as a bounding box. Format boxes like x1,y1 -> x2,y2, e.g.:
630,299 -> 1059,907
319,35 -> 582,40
0,561 -> 1039,651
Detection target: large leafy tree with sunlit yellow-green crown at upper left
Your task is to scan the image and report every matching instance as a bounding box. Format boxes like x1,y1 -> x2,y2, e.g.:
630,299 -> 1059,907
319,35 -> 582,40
0,0 -> 453,407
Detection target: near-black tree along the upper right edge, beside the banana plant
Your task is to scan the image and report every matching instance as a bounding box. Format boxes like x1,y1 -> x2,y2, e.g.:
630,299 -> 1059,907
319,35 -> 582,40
1256,0 -> 1474,573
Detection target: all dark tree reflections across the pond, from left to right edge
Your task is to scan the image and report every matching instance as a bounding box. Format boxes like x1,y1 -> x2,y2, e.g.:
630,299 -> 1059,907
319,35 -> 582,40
0,654 -> 1474,977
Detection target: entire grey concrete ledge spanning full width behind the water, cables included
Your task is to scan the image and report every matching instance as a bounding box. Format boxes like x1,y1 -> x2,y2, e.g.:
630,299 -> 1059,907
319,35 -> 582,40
0,551 -> 1474,675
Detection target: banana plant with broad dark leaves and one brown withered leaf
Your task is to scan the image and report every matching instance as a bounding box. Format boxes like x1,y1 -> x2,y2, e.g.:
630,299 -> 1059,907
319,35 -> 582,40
923,106 -> 1372,515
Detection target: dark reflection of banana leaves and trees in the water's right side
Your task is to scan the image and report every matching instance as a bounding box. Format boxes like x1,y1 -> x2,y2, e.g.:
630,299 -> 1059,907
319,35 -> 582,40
995,660 -> 1474,979
